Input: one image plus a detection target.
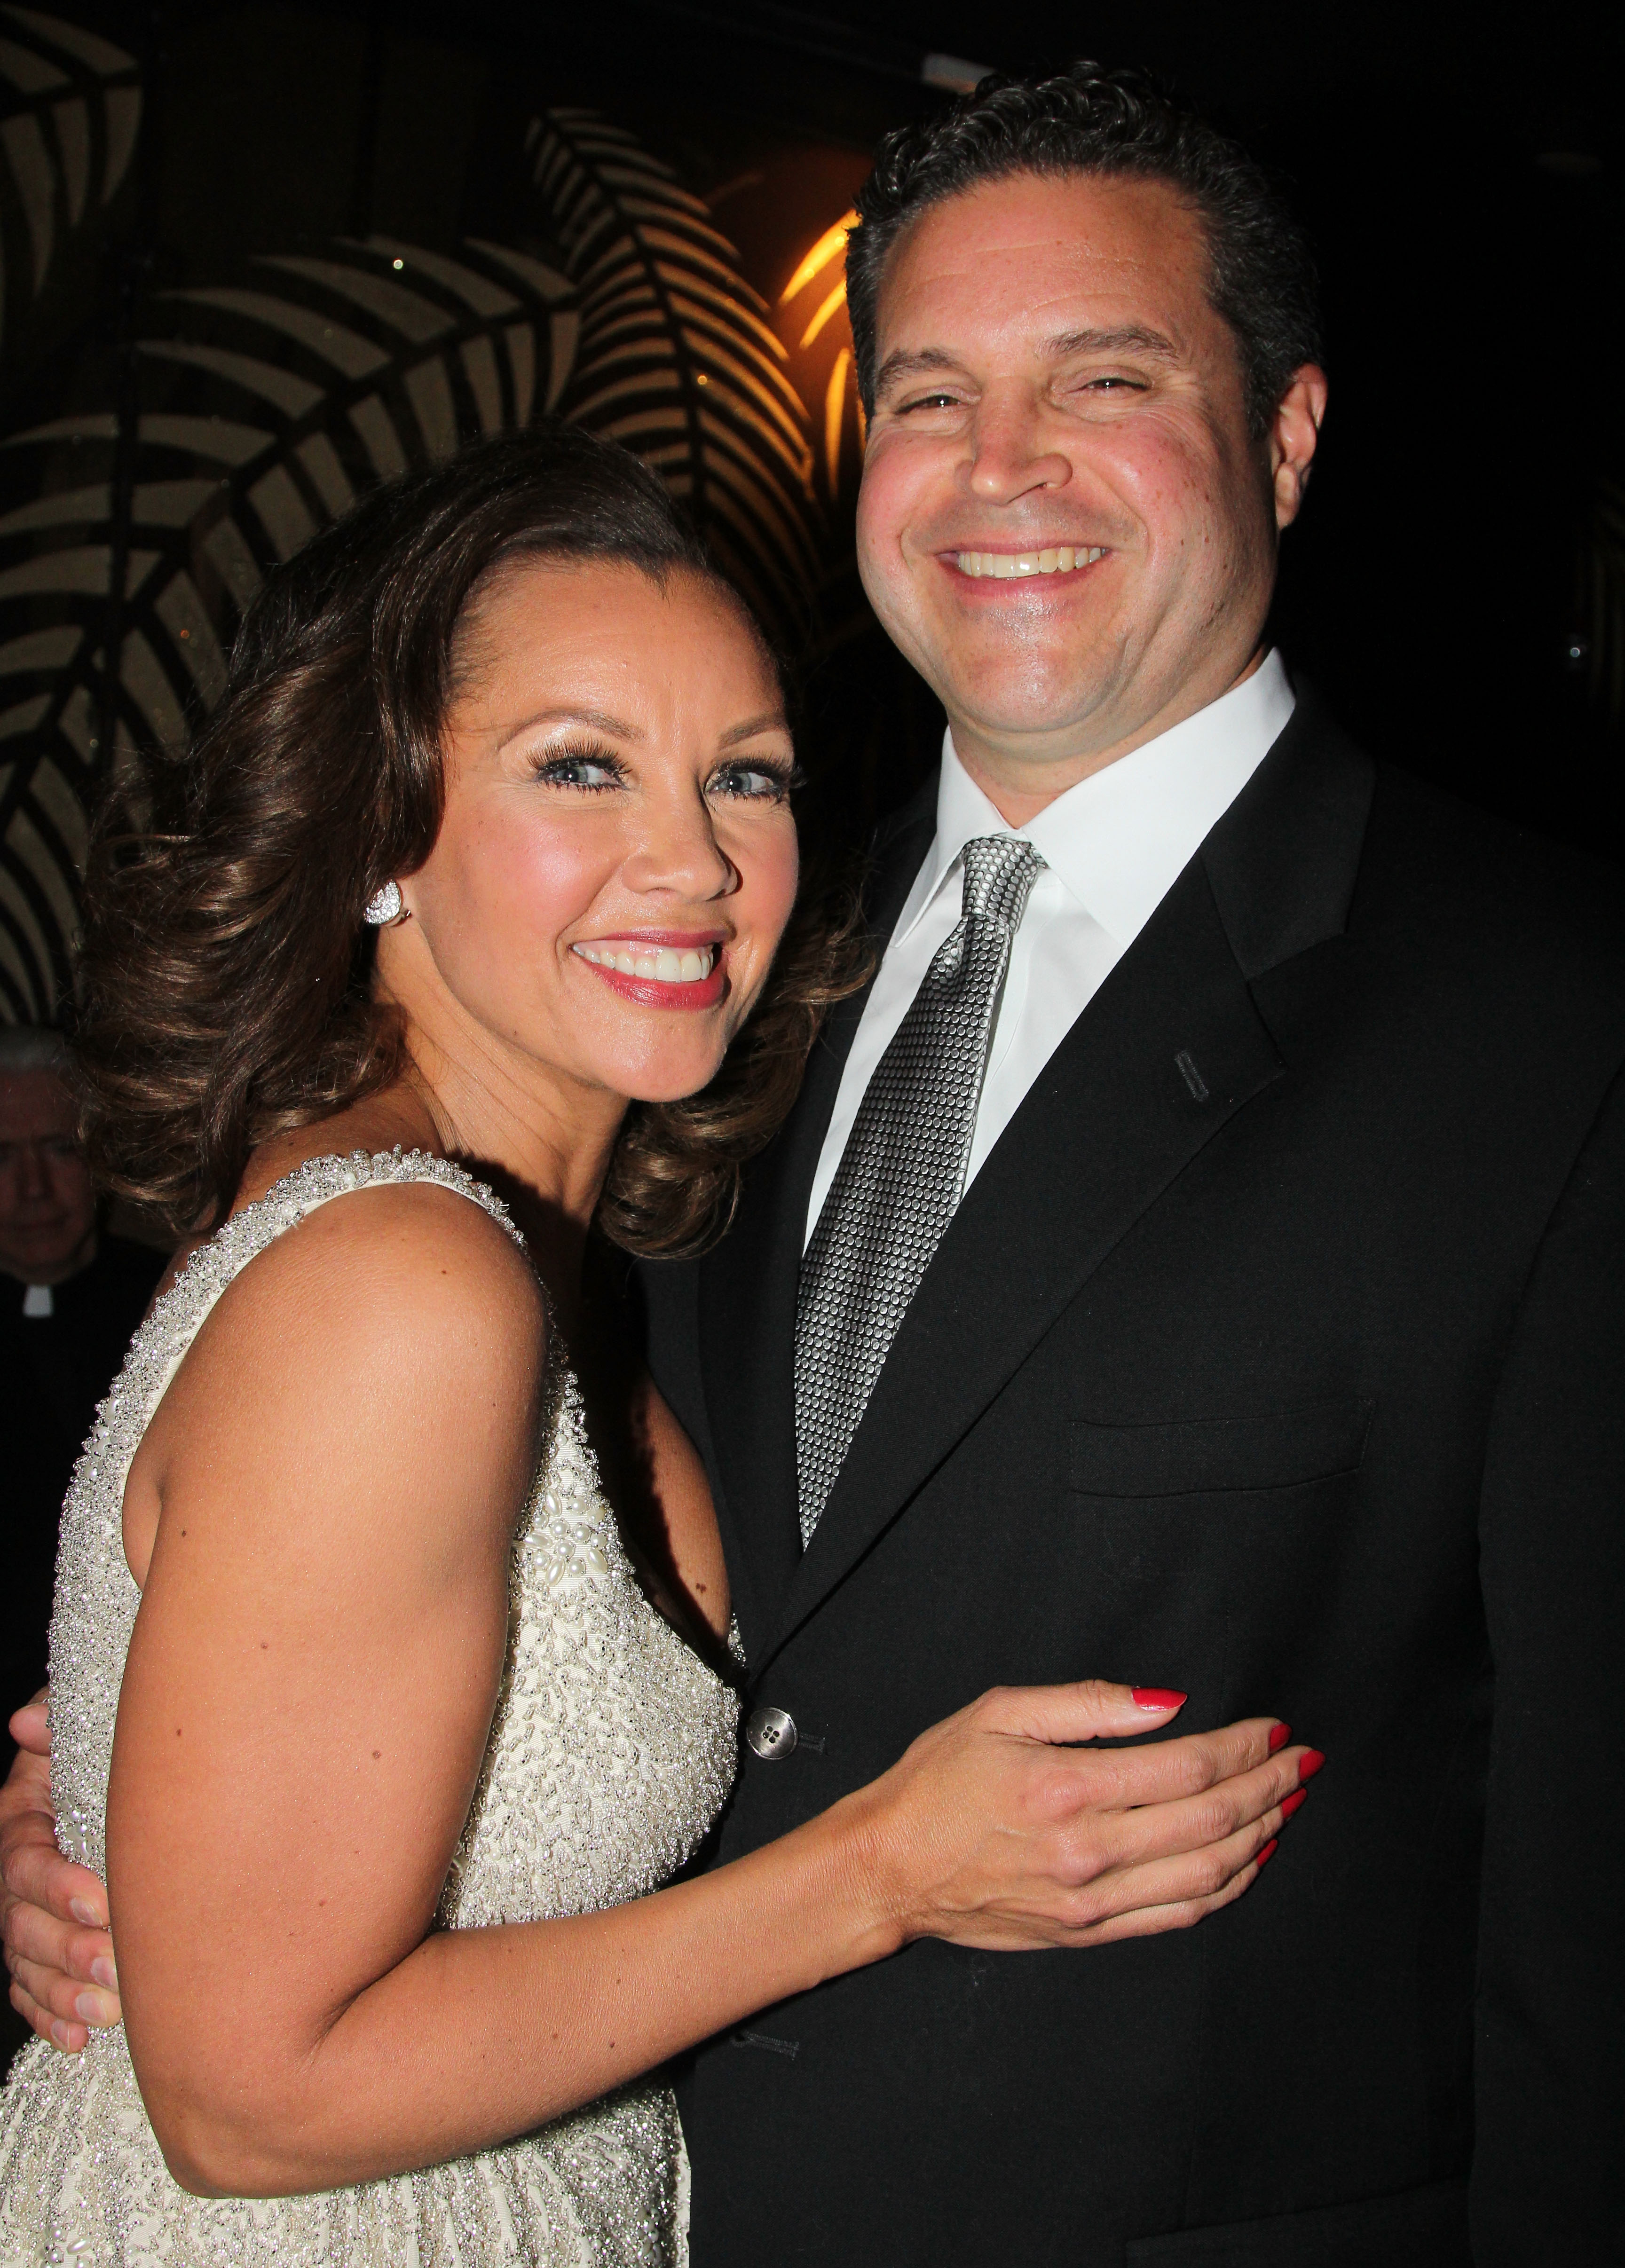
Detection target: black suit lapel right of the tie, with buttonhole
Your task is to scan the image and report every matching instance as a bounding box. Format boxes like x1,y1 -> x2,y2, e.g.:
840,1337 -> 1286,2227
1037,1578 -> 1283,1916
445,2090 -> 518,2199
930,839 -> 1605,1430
751,703 -> 1371,1669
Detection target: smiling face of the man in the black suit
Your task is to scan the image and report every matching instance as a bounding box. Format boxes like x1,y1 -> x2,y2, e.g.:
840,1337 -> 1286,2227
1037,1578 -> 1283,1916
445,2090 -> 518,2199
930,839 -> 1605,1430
858,174 -> 1323,801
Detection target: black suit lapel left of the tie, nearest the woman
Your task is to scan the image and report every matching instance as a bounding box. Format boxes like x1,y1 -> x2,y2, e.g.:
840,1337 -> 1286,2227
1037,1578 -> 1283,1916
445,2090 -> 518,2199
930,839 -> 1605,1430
699,782 -> 935,1660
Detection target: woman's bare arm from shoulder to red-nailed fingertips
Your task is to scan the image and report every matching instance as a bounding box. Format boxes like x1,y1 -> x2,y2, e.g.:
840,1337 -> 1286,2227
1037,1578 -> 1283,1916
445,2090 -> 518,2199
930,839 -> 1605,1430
47,1191 -> 1298,2196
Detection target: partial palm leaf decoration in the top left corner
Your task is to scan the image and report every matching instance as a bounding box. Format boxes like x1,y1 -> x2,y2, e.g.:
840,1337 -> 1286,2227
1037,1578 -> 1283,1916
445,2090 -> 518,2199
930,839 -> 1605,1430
0,7 -> 141,378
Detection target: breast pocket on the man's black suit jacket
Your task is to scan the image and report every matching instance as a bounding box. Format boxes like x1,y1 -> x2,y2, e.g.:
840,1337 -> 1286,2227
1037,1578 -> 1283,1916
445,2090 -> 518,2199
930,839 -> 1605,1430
1069,1397 -> 1373,1499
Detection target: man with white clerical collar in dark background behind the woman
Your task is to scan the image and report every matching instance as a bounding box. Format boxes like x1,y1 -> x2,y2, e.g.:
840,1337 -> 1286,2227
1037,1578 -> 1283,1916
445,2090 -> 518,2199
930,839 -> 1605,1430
0,1027 -> 164,1696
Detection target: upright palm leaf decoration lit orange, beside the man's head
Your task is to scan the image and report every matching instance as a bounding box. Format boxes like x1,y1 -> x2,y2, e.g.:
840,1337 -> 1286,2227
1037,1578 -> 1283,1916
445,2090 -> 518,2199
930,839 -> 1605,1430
531,109 -> 824,635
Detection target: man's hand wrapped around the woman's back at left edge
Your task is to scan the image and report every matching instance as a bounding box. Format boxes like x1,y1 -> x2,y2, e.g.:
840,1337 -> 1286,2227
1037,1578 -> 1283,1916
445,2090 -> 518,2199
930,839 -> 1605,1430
0,1690 -> 123,2055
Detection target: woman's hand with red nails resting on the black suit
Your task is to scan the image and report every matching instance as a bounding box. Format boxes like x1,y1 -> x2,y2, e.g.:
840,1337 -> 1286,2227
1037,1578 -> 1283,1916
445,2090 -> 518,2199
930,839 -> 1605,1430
849,1681 -> 1321,1953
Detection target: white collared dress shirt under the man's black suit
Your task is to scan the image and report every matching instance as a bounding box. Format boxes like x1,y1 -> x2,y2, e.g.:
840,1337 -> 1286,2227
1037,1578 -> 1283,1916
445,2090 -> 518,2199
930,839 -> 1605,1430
806,653 -> 1296,1238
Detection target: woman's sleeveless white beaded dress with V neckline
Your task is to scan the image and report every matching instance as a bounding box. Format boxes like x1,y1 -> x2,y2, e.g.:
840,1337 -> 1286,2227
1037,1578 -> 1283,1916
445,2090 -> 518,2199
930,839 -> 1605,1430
0,1152 -> 738,2268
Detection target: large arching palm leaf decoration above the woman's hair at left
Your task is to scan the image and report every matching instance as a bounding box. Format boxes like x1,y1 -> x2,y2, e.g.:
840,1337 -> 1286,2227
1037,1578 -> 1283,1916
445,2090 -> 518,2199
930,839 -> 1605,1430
0,236 -> 576,1021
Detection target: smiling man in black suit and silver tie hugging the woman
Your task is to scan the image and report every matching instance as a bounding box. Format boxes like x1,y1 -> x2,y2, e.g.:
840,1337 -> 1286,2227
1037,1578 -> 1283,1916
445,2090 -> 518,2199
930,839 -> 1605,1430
7,66 -> 1625,2268
